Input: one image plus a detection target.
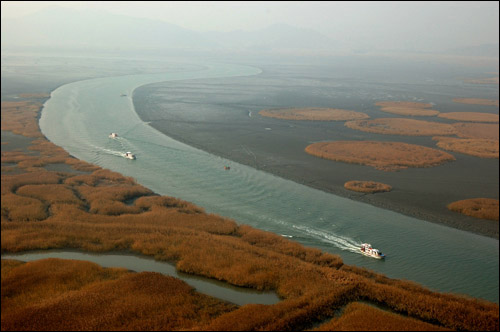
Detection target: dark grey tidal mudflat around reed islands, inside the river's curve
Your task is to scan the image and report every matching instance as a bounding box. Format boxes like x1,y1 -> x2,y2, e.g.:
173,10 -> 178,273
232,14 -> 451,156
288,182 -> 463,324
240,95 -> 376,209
134,64 -> 499,238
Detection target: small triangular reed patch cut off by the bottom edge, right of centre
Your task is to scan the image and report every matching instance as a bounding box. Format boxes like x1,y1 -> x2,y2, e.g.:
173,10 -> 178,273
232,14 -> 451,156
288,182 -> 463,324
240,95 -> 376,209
311,302 -> 451,331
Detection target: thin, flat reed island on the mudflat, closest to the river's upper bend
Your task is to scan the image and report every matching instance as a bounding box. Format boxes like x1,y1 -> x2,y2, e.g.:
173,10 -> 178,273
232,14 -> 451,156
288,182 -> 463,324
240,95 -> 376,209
259,107 -> 370,121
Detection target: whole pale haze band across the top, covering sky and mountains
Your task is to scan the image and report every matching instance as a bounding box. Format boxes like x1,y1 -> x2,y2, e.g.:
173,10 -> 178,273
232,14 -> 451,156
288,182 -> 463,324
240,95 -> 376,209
2,1 -> 499,56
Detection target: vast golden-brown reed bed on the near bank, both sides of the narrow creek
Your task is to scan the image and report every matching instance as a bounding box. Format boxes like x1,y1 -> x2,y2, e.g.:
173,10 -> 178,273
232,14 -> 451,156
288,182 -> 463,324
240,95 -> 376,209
1,97 -> 499,330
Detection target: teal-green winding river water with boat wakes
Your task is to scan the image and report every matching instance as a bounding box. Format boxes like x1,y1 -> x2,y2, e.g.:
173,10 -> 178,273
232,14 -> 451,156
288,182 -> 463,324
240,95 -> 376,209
40,64 -> 499,302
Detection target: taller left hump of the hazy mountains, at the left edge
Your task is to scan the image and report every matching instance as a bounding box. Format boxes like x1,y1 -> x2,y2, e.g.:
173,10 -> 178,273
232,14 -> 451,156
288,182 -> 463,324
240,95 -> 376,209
1,7 -> 217,49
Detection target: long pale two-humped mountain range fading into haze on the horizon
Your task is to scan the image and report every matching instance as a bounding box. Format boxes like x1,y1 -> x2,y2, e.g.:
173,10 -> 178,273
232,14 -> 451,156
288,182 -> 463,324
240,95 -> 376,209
1,7 -> 338,53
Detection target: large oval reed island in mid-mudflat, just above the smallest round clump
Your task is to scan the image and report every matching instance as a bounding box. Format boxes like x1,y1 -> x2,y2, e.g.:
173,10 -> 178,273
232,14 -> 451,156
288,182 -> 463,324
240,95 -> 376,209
305,141 -> 455,171
